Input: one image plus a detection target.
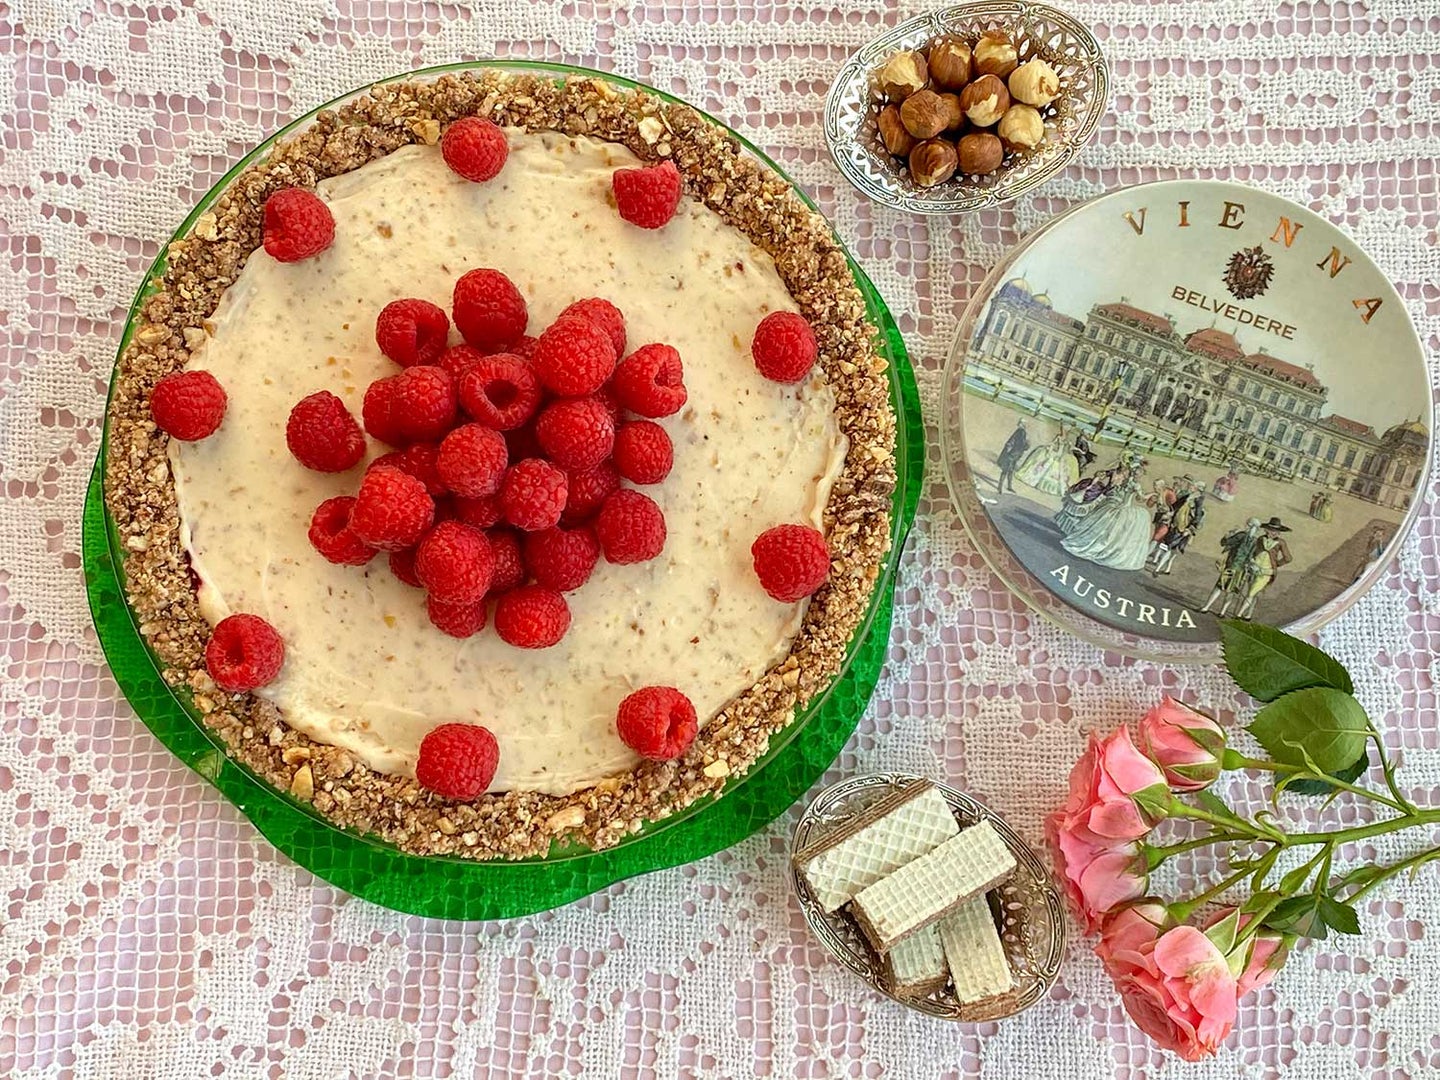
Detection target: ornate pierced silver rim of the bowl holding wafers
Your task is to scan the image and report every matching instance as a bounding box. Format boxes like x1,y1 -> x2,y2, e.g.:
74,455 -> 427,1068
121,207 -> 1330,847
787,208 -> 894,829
788,772 -> 1067,1024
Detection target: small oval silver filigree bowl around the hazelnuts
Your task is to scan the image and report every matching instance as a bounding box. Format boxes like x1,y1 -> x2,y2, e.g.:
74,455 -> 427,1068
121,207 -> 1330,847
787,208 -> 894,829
825,0 -> 1110,215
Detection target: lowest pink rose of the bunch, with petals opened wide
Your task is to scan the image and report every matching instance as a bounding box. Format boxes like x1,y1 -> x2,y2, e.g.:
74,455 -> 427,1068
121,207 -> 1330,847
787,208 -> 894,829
1110,926 -> 1238,1061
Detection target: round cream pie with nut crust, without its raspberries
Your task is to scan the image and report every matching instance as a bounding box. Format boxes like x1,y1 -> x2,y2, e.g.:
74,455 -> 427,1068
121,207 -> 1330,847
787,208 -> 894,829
105,71 -> 896,858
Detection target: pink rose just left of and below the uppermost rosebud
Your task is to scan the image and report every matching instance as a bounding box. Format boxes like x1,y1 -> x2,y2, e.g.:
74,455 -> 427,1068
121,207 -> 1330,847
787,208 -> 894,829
1060,727 -> 1169,847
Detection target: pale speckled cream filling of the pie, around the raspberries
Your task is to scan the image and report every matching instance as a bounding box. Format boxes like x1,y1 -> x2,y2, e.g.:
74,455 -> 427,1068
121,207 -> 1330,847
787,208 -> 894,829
170,131 -> 847,793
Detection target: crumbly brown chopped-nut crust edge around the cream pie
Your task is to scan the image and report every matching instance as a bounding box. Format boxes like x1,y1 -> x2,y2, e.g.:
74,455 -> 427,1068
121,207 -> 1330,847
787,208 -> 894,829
105,71 -> 896,858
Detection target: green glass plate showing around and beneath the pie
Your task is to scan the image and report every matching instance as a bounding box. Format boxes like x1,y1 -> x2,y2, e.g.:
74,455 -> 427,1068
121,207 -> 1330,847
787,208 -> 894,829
84,62 -> 924,919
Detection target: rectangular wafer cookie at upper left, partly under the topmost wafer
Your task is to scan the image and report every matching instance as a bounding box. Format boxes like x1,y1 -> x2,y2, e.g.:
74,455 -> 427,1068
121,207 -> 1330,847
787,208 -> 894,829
795,780 -> 960,912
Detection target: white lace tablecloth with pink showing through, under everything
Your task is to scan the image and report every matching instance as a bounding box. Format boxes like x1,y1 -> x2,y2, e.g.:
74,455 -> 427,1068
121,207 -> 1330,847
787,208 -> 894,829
0,0 -> 1440,1080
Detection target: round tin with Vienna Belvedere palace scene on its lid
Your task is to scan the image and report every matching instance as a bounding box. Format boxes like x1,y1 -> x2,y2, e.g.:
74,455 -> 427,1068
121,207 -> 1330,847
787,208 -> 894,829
942,181 -> 1433,661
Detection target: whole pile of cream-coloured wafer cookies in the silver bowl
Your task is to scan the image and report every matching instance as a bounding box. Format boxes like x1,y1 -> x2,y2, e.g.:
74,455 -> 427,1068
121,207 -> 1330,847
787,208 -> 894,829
795,780 -> 1015,1004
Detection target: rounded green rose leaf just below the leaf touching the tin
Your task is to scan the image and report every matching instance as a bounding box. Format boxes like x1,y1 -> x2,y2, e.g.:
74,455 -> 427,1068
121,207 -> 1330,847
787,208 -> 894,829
1250,687 -> 1369,788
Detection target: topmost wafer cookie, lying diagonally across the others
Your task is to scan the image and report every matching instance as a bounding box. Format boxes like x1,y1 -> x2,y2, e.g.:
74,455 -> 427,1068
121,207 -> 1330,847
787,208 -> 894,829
851,821 -> 1015,953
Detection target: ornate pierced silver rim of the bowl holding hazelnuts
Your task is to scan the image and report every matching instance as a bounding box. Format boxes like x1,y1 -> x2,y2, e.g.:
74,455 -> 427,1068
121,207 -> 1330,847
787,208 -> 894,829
824,0 -> 1110,215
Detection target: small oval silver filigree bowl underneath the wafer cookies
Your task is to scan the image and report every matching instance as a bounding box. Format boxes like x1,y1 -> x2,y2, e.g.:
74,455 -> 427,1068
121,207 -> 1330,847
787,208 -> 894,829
791,773 -> 1066,1024
